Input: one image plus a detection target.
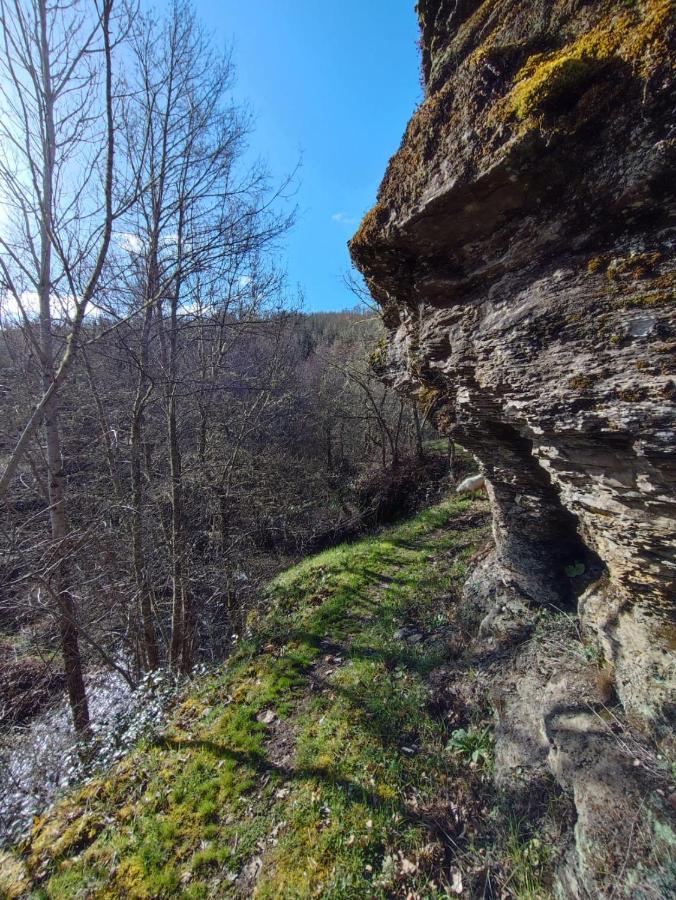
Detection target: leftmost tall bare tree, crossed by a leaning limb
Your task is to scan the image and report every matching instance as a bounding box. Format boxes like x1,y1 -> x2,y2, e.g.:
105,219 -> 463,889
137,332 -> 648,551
0,0 -> 125,733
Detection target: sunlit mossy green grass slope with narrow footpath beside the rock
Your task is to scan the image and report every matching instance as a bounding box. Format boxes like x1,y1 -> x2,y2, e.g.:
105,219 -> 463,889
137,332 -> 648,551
0,498 -> 500,898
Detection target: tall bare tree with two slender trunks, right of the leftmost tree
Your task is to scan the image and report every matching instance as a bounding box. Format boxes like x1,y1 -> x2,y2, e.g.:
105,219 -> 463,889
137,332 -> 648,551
117,0 -> 289,671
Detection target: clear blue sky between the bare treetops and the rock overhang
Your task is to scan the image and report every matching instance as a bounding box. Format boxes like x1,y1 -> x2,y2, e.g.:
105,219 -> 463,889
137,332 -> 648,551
187,0 -> 421,310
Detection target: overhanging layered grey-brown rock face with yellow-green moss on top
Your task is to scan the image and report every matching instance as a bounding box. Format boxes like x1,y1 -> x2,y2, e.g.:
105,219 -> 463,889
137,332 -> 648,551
351,0 -> 676,735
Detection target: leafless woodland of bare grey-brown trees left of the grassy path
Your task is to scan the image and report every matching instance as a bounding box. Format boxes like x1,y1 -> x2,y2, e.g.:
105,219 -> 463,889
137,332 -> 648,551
0,0 -> 447,844
